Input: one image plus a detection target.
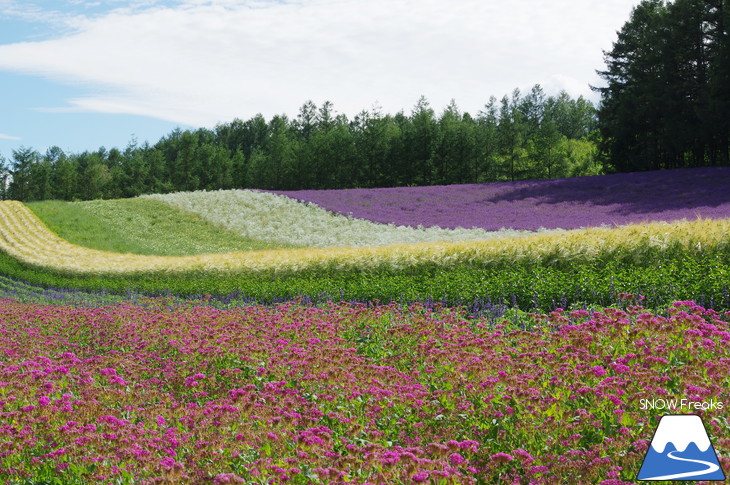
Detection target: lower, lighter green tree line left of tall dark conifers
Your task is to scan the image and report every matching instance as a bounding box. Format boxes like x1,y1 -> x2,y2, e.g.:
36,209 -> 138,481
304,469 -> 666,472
0,85 -> 603,201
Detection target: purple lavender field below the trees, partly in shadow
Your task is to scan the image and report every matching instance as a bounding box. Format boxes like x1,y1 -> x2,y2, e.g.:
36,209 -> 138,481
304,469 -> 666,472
271,167 -> 730,231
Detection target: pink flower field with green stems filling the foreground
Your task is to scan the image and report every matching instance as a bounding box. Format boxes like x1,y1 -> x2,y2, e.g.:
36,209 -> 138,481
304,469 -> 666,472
0,295 -> 730,485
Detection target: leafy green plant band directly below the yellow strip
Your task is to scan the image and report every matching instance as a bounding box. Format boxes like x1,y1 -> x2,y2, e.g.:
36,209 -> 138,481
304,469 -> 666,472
0,248 -> 730,311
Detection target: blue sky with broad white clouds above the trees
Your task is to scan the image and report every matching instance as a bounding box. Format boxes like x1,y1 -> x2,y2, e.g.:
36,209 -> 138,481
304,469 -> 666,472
0,0 -> 638,158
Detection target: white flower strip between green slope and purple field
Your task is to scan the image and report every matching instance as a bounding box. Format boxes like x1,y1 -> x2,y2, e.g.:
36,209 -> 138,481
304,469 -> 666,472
142,190 -> 562,248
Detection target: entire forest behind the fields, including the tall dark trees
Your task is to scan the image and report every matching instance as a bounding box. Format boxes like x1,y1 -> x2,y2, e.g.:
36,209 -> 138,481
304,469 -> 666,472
0,0 -> 730,201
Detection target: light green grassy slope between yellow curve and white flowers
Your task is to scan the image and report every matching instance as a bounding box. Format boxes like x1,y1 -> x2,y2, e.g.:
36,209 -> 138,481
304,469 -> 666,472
27,199 -> 294,256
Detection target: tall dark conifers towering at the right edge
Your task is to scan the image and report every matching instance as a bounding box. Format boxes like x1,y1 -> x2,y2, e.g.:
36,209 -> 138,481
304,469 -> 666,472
597,0 -> 730,171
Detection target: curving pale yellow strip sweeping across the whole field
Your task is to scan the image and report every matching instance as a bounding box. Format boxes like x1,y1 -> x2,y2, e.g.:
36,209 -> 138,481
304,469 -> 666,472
0,201 -> 730,274
